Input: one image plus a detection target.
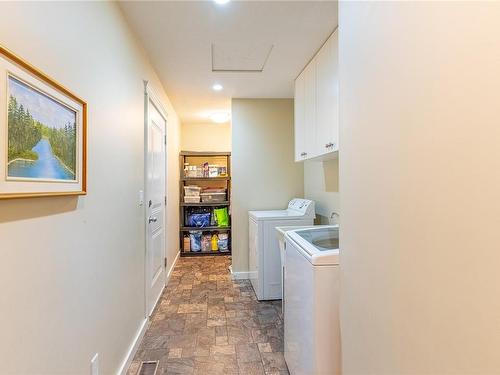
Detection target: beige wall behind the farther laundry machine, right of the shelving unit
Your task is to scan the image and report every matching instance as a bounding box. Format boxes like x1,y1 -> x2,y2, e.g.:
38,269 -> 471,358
232,99 -> 304,272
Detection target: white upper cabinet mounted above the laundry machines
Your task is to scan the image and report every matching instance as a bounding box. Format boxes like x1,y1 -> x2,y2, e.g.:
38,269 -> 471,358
295,27 -> 339,161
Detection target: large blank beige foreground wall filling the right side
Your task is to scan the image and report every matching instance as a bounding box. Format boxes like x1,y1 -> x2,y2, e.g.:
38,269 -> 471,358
339,2 -> 500,375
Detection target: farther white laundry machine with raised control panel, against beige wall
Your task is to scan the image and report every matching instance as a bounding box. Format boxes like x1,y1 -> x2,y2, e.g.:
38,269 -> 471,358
248,198 -> 315,301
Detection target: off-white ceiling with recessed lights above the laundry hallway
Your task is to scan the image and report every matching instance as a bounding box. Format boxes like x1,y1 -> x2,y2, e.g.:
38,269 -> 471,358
119,1 -> 337,123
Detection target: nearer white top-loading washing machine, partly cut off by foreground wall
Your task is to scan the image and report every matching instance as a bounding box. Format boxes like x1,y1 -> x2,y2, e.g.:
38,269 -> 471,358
284,225 -> 341,375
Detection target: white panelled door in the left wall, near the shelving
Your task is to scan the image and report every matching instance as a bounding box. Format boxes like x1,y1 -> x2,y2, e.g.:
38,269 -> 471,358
145,91 -> 167,316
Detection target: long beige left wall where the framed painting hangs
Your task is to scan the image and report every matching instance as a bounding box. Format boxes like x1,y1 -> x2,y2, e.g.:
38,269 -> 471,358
0,2 -> 179,375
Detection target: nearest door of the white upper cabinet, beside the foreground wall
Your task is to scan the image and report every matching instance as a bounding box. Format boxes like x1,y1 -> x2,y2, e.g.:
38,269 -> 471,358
315,31 -> 339,155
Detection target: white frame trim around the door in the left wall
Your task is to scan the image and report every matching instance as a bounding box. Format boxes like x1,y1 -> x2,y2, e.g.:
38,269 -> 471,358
143,80 -> 168,319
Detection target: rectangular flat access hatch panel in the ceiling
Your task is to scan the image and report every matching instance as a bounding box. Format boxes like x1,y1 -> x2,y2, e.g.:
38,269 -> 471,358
212,43 -> 274,73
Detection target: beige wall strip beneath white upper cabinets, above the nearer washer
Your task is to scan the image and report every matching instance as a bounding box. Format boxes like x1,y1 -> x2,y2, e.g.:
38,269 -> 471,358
304,158 -> 340,224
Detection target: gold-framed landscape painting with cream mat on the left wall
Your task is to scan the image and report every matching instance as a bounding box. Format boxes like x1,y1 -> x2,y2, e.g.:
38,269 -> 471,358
0,46 -> 87,199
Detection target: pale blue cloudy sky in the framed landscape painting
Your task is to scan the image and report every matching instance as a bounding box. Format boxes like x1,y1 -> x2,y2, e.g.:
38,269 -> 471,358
9,76 -> 76,129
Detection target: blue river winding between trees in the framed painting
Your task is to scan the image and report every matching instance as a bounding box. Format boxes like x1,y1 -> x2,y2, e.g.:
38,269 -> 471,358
8,138 -> 75,180
